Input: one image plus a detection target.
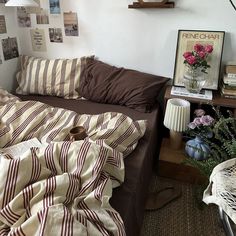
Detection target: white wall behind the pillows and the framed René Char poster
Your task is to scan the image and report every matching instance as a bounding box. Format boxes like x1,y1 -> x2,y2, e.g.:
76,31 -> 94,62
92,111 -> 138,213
1,0 -> 236,91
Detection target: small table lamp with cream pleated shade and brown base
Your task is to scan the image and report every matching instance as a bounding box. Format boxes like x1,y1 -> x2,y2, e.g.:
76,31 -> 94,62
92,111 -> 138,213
164,98 -> 190,149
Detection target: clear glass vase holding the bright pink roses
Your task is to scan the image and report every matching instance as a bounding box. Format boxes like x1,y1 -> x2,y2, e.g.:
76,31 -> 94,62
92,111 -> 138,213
183,67 -> 206,93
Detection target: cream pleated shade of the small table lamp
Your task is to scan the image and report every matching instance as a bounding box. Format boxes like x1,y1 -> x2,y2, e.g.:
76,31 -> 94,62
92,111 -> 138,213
164,98 -> 190,132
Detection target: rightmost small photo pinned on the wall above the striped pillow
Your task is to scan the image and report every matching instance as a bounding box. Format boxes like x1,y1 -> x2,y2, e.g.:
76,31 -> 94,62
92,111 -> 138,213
64,12 -> 79,36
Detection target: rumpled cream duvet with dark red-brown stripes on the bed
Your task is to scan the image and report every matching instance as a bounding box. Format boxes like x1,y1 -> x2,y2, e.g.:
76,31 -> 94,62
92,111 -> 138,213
0,97 -> 146,236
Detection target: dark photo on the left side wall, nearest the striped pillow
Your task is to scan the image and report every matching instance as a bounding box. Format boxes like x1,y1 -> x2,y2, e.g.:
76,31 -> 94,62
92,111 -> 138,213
2,37 -> 19,61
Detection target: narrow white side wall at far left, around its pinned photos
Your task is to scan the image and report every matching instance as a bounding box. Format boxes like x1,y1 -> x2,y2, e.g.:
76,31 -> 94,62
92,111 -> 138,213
0,3 -> 21,91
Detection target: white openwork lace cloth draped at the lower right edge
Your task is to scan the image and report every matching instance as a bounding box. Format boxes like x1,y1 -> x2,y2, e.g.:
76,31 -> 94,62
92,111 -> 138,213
202,158 -> 236,224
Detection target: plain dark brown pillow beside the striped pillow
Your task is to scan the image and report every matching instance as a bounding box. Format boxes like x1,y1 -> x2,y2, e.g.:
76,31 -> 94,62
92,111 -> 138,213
79,59 -> 169,112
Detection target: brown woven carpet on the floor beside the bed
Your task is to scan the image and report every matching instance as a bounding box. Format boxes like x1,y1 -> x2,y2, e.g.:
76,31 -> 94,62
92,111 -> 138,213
141,175 -> 225,236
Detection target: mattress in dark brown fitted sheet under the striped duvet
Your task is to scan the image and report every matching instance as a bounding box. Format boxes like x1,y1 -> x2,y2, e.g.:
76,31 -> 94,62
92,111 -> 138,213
19,95 -> 160,236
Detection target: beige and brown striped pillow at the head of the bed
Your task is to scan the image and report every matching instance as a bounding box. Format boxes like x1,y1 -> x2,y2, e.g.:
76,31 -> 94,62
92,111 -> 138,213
16,55 -> 90,99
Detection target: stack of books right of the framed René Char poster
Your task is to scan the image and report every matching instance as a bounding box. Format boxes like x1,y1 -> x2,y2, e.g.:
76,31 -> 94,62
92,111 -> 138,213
220,63 -> 236,98
